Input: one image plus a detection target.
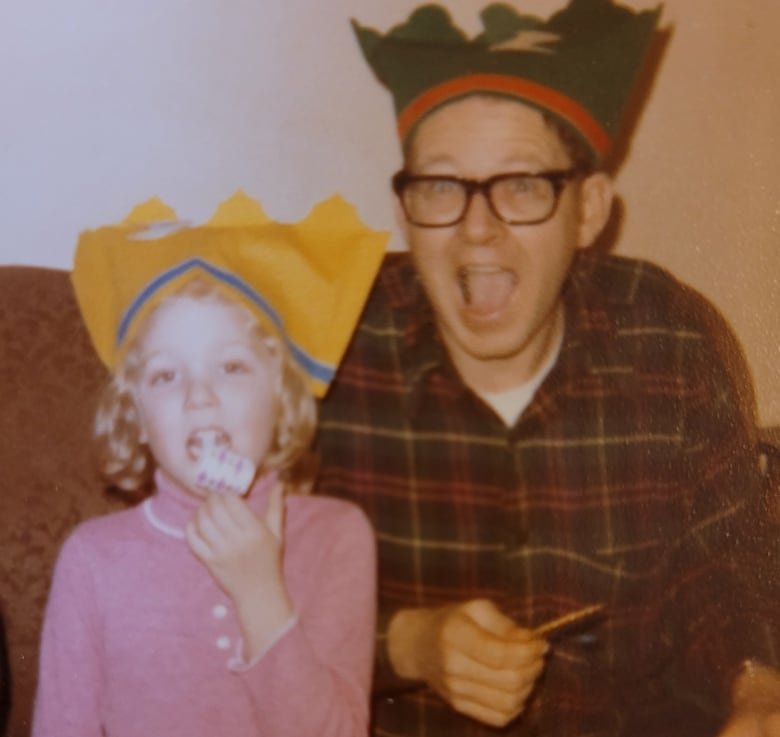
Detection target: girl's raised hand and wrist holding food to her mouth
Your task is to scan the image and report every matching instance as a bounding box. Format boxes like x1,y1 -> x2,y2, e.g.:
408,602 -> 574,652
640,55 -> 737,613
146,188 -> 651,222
185,483 -> 293,660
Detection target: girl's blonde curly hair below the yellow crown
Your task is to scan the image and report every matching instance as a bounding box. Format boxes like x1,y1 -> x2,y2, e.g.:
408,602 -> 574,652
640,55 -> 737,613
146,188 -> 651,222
94,278 -> 317,492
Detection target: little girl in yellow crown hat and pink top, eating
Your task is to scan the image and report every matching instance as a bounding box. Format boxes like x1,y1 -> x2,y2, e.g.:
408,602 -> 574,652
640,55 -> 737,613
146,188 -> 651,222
33,197 -> 385,737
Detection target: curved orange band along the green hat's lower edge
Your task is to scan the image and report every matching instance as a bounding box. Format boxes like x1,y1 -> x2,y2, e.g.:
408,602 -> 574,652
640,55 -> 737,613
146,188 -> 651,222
397,74 -> 611,157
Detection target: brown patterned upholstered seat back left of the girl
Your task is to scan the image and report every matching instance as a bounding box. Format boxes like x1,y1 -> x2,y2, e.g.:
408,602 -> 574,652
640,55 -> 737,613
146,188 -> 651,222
0,266 -> 123,737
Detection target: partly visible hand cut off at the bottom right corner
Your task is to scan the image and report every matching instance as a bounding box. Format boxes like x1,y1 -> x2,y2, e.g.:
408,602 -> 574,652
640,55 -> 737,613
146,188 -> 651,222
718,662 -> 780,737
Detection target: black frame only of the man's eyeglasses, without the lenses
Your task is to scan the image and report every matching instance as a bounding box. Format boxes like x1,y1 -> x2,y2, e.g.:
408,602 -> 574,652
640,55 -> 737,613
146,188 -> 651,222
391,167 -> 582,228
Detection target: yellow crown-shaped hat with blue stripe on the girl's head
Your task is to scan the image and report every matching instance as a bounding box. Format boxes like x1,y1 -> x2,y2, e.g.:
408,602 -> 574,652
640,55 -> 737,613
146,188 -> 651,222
71,193 -> 388,396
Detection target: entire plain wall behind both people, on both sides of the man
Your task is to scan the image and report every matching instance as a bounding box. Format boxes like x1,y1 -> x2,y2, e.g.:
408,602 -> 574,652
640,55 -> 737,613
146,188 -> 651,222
0,0 -> 780,424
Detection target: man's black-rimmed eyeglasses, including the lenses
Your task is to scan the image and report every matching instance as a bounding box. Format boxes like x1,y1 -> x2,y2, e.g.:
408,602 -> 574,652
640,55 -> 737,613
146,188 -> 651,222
392,169 -> 579,228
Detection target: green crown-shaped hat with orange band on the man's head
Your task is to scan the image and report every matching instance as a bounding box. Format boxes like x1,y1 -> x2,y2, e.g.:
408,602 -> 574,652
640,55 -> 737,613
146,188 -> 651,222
352,0 -> 660,160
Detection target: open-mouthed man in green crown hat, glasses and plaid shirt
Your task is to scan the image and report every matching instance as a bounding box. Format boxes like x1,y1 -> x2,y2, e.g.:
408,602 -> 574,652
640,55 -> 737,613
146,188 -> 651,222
319,0 -> 780,737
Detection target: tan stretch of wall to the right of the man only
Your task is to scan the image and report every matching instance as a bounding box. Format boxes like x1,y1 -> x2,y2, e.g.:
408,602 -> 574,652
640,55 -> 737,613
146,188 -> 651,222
618,0 -> 780,424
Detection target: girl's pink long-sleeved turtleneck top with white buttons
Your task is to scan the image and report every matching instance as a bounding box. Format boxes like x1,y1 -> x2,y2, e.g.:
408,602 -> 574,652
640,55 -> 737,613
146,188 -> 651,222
33,475 -> 376,737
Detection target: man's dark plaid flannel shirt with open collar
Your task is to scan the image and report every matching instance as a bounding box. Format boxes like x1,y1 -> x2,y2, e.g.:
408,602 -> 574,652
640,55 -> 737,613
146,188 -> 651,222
318,253 -> 780,737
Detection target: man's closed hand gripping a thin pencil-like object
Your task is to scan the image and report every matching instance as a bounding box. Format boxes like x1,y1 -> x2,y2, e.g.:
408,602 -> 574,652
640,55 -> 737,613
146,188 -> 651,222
388,599 -> 548,727
